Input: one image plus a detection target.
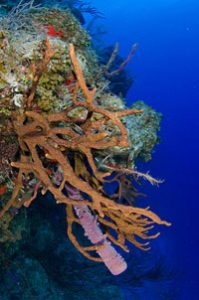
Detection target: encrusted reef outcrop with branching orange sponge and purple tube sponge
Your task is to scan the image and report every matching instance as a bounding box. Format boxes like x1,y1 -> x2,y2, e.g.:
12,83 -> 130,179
0,4 -> 169,275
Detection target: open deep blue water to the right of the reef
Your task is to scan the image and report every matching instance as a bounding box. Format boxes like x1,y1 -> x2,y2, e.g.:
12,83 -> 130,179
92,0 -> 199,300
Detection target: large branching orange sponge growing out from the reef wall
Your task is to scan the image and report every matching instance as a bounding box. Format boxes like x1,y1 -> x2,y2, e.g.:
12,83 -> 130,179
0,40 -> 169,268
